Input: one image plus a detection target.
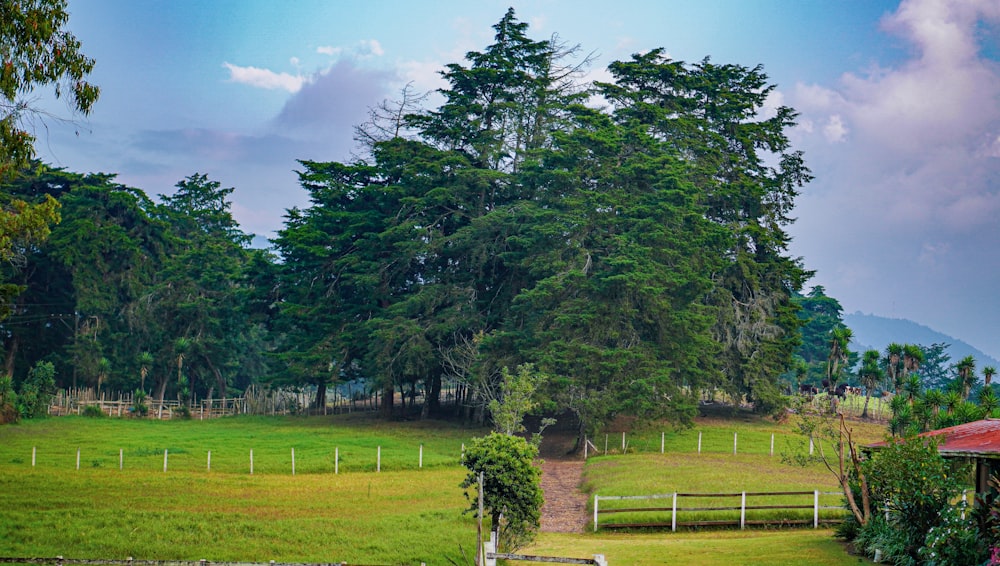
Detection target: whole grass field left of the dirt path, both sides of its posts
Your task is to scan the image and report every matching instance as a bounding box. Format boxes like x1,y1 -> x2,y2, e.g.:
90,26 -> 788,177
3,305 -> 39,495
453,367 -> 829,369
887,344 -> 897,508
0,417 -> 482,564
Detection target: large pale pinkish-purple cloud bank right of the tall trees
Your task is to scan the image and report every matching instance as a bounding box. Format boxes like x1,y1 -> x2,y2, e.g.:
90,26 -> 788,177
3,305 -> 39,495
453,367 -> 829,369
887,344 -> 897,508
786,0 -> 1000,354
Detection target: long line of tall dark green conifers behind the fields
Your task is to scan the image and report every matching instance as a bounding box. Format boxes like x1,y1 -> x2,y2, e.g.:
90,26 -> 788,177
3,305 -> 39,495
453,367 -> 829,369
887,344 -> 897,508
3,11 -> 810,434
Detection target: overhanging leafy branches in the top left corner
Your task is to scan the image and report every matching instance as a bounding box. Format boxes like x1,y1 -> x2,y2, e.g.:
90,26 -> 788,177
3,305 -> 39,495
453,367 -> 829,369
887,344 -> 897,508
0,0 -> 100,178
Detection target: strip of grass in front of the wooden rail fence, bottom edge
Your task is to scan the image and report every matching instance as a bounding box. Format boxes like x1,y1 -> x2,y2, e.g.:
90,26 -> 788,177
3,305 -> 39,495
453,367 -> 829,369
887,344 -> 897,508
521,529 -> 871,566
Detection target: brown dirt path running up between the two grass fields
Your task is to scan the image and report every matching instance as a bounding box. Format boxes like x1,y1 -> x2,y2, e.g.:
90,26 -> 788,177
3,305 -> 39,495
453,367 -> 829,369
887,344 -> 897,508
540,433 -> 587,533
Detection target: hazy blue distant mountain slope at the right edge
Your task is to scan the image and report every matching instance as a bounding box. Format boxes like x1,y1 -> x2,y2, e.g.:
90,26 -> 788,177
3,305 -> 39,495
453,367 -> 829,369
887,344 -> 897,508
844,312 -> 1000,368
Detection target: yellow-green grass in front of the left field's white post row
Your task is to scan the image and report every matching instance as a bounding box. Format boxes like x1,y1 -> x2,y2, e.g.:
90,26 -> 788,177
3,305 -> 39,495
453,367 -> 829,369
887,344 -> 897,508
0,468 -> 475,564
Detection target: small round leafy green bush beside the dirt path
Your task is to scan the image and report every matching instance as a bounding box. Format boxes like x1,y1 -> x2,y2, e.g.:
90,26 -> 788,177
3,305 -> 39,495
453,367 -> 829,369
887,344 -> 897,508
461,432 -> 543,552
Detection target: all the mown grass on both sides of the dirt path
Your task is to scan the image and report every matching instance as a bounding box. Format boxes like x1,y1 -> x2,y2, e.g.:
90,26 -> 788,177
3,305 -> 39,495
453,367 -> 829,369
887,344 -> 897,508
0,415 -> 877,566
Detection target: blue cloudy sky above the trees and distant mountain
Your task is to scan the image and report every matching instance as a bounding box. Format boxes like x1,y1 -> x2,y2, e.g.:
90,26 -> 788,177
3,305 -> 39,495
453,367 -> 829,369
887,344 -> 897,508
27,0 -> 1000,357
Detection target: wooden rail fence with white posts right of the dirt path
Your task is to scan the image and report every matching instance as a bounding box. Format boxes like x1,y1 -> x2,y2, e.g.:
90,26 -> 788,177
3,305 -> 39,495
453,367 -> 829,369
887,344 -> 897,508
594,491 -> 843,532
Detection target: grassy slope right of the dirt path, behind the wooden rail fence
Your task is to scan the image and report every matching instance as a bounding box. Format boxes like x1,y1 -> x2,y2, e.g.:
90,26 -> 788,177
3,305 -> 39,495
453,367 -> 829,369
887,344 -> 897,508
585,416 -> 884,525
